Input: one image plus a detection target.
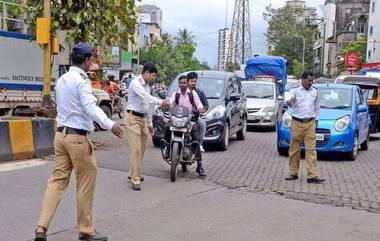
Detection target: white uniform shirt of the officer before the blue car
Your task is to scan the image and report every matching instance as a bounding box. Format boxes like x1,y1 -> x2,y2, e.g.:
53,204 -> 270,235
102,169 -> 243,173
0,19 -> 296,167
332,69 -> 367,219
287,85 -> 320,120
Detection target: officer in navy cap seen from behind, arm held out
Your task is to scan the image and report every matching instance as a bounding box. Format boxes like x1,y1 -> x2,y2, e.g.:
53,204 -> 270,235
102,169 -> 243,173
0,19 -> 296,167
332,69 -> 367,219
35,43 -> 123,241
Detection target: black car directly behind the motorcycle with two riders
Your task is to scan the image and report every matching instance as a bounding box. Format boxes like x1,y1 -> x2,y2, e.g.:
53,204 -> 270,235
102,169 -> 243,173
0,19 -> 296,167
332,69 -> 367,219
152,71 -> 247,150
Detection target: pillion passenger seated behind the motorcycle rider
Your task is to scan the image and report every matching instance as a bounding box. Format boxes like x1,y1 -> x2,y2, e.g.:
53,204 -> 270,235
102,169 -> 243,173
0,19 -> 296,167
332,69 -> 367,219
187,72 -> 209,152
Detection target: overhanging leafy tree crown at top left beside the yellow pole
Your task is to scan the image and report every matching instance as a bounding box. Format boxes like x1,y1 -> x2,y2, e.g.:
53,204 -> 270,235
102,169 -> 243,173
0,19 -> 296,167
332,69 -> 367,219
26,0 -> 137,49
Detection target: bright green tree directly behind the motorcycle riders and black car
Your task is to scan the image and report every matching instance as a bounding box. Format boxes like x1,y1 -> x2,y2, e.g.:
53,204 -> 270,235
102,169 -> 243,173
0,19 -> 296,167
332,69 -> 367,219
140,29 -> 205,85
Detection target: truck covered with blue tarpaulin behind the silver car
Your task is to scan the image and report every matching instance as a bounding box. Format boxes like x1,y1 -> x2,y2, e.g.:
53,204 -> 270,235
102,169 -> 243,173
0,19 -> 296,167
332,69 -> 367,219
244,56 -> 288,96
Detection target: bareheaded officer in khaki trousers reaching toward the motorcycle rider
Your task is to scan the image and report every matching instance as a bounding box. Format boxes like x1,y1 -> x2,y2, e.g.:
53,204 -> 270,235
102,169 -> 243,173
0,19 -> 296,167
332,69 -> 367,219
125,63 -> 170,190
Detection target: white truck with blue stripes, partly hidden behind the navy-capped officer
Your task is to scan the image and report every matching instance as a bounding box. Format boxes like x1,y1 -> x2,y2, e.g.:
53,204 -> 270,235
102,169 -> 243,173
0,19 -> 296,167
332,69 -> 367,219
0,31 -> 112,117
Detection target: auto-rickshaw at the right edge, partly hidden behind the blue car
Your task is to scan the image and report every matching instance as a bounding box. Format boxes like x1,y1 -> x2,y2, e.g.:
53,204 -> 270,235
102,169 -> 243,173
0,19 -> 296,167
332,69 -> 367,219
336,75 -> 380,133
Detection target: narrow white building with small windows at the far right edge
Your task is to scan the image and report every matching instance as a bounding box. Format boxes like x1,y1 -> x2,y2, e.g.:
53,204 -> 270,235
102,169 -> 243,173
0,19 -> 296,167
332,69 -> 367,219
367,0 -> 380,63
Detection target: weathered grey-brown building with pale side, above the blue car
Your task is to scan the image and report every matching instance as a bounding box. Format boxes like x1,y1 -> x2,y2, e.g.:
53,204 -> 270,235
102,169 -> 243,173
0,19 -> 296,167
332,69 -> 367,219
314,0 -> 370,77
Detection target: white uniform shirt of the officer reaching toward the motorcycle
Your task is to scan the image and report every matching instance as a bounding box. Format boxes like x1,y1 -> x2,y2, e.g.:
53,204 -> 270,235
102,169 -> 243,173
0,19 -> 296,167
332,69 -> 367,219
127,75 -> 163,127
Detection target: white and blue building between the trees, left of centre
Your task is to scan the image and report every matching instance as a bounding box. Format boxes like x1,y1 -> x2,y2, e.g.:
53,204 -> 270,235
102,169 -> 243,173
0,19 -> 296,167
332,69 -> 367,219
138,4 -> 162,48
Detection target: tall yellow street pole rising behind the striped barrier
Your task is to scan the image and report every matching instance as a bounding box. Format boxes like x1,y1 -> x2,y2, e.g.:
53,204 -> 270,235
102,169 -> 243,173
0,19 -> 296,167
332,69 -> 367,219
42,0 -> 52,107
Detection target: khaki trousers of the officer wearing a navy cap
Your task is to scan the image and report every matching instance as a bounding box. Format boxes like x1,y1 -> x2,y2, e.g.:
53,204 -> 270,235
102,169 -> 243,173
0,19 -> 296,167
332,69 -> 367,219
38,132 -> 97,235
